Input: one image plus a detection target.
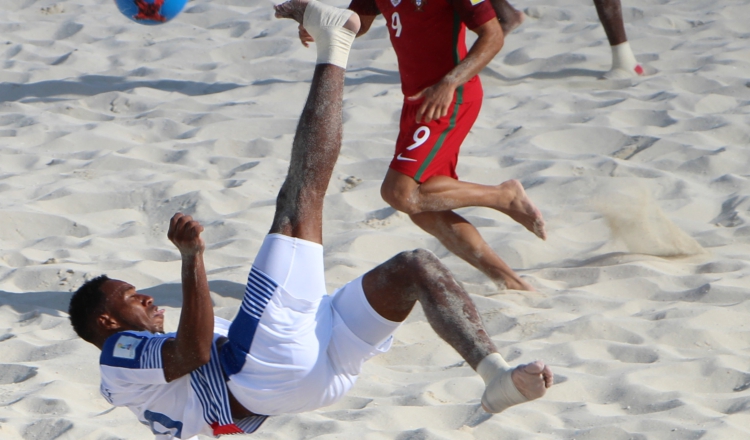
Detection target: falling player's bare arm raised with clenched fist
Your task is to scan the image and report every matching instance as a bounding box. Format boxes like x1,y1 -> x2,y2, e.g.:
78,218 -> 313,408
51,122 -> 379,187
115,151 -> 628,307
162,212 -> 214,382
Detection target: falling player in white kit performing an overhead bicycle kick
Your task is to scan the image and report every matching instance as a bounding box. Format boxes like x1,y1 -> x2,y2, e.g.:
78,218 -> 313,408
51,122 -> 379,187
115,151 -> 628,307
69,0 -> 553,440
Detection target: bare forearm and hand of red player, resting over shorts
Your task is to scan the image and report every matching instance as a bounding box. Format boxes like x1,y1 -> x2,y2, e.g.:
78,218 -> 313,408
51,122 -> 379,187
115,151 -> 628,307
408,20 -> 504,122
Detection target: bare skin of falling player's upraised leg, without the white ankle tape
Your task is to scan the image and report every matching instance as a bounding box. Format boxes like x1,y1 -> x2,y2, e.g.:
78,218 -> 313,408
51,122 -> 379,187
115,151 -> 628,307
270,0 -> 359,243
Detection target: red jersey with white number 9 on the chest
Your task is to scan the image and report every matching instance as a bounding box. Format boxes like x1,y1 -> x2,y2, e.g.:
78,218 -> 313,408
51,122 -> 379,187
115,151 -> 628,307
349,0 -> 497,101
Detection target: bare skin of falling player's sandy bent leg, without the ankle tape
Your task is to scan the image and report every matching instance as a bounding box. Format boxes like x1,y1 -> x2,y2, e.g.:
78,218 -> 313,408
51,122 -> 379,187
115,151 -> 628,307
362,250 -> 554,412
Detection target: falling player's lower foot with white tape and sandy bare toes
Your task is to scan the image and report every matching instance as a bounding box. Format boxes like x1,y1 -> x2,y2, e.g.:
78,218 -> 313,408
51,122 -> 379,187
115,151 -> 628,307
482,361 -> 554,413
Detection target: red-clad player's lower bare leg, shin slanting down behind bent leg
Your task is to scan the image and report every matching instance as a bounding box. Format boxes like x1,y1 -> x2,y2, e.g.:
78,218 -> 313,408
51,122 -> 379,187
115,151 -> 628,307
410,211 -> 534,290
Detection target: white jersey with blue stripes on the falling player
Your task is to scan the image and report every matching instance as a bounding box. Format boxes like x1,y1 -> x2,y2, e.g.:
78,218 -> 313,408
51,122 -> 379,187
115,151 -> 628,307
99,318 -> 267,440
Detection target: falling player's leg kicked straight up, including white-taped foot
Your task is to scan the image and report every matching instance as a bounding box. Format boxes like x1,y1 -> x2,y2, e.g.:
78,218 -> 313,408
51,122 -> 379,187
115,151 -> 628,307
270,0 -> 360,243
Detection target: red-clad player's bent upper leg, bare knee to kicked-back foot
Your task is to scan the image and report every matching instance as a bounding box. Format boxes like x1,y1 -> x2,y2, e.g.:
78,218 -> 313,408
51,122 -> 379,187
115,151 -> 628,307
380,169 -> 547,240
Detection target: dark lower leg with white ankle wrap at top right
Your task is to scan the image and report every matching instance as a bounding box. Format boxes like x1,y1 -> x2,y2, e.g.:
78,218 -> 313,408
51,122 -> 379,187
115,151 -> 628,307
594,0 -> 643,78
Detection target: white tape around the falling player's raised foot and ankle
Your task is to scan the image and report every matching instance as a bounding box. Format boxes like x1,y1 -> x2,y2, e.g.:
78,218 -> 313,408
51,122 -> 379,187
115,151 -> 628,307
302,0 -> 357,69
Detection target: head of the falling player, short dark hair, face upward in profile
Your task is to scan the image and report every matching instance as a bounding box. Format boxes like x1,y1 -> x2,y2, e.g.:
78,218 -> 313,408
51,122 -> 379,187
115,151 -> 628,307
68,275 -> 164,345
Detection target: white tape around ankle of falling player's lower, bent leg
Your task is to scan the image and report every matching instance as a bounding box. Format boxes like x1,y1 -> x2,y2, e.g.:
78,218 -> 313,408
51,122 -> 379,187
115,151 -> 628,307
477,353 -> 529,413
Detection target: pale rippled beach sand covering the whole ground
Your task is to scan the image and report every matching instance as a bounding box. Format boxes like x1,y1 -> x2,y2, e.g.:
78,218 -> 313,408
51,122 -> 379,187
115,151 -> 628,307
0,0 -> 750,440
